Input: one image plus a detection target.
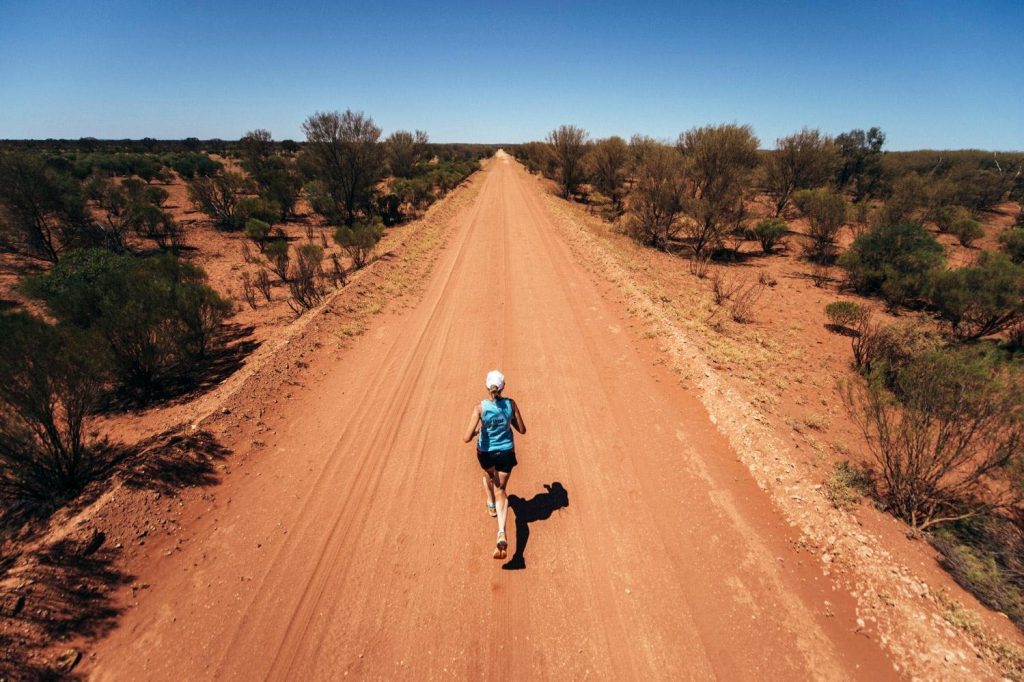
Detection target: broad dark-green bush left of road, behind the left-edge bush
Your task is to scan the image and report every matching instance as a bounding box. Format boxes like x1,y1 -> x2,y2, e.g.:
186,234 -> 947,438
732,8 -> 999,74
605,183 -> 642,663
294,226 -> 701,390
25,249 -> 230,388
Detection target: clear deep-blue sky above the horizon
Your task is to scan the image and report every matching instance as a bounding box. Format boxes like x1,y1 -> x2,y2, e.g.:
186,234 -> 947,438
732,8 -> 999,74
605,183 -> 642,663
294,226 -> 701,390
0,0 -> 1024,151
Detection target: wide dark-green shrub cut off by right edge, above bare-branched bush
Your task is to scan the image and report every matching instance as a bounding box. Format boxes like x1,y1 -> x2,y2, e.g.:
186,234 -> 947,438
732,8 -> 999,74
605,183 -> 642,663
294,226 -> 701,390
929,251 -> 1024,340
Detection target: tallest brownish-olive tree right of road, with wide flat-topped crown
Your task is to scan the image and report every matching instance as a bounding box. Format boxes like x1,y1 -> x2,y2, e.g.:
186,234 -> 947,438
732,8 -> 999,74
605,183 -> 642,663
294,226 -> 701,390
677,124 -> 759,258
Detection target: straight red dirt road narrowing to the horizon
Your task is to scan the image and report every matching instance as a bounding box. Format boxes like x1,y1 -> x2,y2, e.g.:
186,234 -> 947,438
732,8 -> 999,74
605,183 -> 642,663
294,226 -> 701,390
89,156 -> 895,680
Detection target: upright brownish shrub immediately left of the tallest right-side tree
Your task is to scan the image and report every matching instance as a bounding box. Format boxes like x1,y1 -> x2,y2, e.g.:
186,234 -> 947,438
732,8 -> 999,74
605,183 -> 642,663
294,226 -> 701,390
626,145 -> 683,249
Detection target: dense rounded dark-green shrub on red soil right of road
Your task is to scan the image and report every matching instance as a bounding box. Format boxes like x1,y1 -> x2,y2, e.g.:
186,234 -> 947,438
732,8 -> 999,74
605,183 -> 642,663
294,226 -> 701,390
839,223 -> 945,305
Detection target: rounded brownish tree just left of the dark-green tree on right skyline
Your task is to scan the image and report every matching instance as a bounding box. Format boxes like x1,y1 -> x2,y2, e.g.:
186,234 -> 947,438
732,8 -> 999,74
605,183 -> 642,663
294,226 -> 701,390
765,128 -> 839,216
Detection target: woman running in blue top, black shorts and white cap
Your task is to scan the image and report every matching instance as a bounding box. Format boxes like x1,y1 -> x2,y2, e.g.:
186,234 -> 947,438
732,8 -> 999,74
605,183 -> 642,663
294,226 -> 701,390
462,370 -> 526,559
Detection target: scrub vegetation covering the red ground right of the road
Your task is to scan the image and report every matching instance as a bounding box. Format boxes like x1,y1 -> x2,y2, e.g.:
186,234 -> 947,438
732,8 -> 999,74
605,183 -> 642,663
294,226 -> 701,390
514,124 -> 1024,627
